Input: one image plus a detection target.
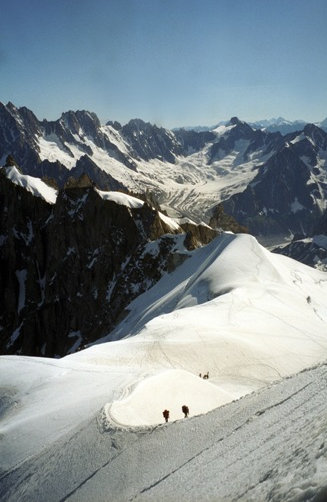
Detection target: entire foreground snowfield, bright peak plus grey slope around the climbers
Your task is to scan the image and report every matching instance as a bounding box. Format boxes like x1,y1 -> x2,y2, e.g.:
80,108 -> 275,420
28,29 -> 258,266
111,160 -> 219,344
0,234 -> 327,502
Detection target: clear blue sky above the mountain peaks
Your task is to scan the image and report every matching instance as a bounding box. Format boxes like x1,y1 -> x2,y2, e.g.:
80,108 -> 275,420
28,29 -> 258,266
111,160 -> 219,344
0,0 -> 327,127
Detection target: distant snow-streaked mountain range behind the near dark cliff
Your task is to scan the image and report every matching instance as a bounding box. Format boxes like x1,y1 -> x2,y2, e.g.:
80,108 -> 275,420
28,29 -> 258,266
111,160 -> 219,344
0,103 -> 327,236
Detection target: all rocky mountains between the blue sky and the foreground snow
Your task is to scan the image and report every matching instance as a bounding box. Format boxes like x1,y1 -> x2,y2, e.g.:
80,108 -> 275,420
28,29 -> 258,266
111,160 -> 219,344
0,103 -> 327,356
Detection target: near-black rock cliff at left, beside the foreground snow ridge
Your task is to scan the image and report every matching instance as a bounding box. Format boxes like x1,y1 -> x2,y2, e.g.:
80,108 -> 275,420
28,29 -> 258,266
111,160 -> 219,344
0,170 -> 216,357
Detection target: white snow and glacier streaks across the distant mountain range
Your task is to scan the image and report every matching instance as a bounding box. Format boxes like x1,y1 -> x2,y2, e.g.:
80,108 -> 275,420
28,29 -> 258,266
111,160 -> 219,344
38,129 -> 272,221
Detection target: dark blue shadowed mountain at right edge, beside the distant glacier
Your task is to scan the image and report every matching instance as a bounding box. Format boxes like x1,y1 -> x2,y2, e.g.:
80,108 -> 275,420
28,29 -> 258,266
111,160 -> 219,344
224,124 -> 327,239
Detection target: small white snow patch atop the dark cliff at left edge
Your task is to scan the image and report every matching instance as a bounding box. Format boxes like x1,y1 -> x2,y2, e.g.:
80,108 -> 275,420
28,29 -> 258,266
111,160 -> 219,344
2,166 -> 57,204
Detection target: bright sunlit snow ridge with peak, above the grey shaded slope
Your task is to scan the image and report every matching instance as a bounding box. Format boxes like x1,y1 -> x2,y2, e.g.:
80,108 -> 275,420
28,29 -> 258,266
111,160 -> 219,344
0,234 -> 327,500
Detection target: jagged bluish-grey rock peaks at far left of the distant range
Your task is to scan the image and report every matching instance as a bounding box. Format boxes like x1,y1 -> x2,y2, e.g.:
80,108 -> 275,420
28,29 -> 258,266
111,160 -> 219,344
0,103 -> 135,189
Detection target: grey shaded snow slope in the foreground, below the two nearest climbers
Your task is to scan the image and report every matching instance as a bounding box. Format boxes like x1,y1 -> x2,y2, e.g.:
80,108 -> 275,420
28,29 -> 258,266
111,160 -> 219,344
0,365 -> 327,502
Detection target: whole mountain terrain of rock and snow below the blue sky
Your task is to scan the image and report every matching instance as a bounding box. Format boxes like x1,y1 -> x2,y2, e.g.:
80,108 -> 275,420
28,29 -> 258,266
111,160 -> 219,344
0,103 -> 327,502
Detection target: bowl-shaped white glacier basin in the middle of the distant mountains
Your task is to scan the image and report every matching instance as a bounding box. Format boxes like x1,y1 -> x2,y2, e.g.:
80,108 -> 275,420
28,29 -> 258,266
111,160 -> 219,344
140,140 -> 271,221
